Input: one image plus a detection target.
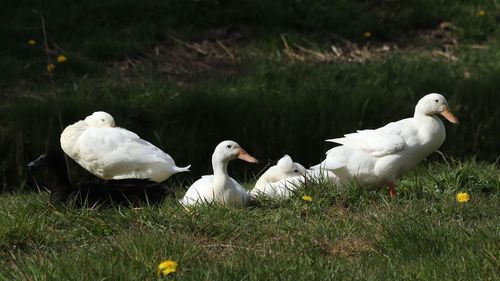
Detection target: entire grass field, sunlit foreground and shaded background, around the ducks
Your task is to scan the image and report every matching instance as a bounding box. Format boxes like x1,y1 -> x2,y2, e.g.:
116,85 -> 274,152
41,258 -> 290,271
0,0 -> 500,280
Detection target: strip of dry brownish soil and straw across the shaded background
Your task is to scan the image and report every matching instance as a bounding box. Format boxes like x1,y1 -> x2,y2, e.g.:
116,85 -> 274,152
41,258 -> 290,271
112,22 -> 480,82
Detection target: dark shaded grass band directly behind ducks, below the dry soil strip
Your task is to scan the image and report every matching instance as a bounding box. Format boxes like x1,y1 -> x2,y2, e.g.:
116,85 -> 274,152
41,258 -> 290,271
0,45 -> 500,190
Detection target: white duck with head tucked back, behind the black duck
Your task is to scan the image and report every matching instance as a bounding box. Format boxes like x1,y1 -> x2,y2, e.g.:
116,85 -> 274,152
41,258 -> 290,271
60,111 -> 190,182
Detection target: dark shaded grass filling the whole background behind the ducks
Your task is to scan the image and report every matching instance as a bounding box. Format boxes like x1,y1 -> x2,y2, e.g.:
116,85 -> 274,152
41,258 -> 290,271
0,1 -> 500,191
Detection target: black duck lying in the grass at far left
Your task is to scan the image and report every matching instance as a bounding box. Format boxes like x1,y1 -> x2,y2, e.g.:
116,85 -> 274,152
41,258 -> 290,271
28,149 -> 174,206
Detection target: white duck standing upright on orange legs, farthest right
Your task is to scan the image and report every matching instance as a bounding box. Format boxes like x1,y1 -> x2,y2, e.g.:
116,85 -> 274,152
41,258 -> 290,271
311,93 -> 458,197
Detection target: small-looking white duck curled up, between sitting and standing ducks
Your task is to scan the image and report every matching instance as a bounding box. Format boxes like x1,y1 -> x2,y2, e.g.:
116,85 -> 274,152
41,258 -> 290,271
250,155 -> 306,199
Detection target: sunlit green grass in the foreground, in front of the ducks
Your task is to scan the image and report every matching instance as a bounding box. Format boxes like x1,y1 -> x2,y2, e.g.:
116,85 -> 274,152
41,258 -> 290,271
0,161 -> 500,280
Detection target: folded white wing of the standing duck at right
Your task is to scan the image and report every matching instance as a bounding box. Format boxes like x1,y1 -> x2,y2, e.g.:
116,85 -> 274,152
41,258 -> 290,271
327,119 -> 409,157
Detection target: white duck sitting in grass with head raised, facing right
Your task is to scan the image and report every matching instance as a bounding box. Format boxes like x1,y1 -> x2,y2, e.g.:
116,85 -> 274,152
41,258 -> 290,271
180,140 -> 259,207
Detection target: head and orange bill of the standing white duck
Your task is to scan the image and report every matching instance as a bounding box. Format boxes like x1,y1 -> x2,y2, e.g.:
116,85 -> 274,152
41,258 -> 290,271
415,93 -> 458,124
